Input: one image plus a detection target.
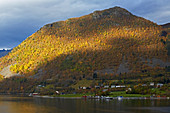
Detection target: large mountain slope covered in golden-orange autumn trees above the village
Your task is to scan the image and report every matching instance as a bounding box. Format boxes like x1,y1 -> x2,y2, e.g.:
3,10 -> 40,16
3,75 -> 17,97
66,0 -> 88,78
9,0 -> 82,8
0,7 -> 170,79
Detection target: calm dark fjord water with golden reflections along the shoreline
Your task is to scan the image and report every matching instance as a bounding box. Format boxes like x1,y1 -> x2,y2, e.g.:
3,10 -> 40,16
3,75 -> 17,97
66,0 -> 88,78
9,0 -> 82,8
0,96 -> 170,113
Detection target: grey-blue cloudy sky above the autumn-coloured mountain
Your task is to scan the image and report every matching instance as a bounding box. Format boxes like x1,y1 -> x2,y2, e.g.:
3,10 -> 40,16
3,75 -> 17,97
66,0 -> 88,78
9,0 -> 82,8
0,0 -> 170,49
